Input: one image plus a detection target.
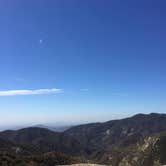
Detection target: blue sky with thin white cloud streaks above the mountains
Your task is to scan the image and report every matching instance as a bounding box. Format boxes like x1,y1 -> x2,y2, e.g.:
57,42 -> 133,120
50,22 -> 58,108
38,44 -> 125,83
0,0 -> 166,126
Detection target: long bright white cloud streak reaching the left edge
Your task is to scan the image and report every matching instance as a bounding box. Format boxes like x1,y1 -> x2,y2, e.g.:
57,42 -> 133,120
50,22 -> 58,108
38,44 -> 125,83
0,88 -> 63,96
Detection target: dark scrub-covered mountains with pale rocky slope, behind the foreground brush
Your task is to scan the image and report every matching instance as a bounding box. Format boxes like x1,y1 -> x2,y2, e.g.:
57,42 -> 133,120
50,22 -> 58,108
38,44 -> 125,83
0,113 -> 166,166
